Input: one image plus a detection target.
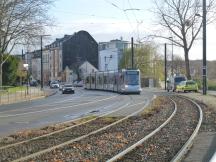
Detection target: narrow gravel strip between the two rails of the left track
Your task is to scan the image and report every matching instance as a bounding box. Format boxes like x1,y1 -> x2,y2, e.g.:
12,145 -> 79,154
0,117 -> 119,162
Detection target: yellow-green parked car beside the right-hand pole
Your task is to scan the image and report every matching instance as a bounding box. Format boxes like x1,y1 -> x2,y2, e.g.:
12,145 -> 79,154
176,80 -> 198,92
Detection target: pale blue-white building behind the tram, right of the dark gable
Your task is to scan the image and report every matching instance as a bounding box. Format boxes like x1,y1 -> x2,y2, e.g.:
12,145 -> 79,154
98,38 -> 131,71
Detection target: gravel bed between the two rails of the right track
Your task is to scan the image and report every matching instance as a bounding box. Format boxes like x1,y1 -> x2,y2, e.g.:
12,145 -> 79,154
118,97 -> 199,162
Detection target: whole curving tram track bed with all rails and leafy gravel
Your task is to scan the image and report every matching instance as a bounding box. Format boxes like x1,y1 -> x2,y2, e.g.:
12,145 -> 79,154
0,96 -> 202,162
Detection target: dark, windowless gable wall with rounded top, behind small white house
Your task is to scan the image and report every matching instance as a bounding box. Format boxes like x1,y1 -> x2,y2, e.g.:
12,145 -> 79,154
62,31 -> 98,69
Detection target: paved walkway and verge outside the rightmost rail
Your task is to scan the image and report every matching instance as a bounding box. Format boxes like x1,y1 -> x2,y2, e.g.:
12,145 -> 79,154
179,91 -> 216,162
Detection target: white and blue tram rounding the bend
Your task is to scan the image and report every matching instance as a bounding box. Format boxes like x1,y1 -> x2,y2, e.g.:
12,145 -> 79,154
85,69 -> 142,94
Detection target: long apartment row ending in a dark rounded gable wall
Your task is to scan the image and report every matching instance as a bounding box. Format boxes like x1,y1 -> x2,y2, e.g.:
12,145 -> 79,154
27,31 -> 98,83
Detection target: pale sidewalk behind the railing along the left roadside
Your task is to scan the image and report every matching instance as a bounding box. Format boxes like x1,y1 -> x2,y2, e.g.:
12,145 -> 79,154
0,87 -> 57,105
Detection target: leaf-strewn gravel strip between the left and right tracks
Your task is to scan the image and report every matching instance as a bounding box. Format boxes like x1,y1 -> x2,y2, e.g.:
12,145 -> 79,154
28,97 -> 174,162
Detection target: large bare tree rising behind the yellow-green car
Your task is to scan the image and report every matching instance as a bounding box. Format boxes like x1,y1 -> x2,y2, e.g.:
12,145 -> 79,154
154,0 -> 215,79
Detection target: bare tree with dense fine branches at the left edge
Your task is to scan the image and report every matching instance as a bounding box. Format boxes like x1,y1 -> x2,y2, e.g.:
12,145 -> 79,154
0,0 -> 54,86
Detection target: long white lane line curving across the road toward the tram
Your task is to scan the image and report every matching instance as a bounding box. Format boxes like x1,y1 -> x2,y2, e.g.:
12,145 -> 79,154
0,95 -> 117,118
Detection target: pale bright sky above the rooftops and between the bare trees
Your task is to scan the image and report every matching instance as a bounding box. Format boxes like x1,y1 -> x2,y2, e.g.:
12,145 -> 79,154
47,0 -> 216,60
